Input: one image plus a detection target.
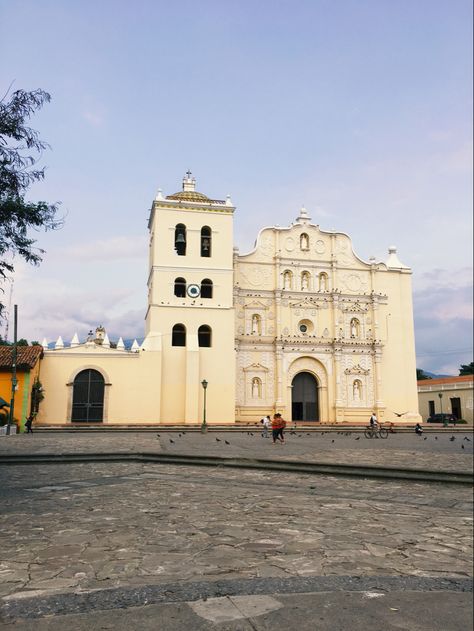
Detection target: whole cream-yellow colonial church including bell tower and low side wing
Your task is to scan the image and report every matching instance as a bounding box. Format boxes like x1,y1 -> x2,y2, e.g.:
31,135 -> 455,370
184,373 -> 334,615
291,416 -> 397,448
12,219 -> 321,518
37,172 -> 419,424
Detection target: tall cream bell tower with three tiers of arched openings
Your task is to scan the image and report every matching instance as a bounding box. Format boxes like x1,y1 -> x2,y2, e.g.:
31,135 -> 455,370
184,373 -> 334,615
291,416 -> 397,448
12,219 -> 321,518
144,171 -> 235,424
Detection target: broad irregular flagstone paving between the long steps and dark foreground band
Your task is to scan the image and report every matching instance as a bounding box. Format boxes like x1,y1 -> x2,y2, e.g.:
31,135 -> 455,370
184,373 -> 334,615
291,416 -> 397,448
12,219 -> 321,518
0,463 -> 472,598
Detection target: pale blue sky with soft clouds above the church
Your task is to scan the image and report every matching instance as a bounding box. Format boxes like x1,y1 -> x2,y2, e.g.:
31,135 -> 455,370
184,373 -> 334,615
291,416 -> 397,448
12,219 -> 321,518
0,0 -> 472,374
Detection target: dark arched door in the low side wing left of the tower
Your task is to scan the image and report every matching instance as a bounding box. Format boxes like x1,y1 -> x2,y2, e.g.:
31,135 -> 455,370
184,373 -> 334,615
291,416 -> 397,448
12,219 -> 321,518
71,369 -> 105,423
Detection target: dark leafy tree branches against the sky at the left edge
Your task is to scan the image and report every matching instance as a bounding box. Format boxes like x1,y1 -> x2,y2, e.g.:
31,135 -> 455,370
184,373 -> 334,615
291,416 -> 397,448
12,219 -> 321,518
0,90 -> 62,314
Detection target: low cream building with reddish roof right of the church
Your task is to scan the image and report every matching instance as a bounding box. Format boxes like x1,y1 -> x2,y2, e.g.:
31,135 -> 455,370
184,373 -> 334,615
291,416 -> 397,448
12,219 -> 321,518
418,375 -> 474,425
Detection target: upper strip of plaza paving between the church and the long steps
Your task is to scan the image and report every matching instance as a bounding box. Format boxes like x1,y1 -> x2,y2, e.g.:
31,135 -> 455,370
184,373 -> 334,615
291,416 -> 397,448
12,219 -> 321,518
0,428 -> 474,471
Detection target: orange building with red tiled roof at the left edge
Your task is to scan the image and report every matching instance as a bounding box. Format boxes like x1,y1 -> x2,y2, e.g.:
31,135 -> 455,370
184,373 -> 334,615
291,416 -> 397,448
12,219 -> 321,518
0,346 -> 43,431
